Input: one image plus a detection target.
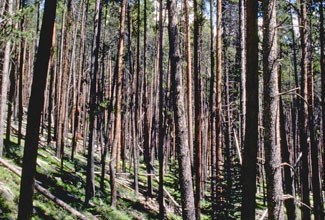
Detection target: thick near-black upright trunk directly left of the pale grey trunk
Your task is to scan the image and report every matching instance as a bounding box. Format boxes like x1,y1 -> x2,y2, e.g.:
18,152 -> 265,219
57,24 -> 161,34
241,0 -> 259,220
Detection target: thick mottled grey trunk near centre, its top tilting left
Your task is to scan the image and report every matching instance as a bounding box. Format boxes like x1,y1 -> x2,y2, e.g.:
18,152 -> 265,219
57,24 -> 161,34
168,0 -> 195,219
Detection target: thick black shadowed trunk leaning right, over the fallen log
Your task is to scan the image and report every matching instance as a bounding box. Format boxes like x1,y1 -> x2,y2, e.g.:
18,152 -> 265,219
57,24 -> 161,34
18,0 -> 57,217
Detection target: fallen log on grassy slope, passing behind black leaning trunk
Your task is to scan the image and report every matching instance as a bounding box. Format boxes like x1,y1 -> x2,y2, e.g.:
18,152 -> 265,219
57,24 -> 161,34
0,158 -> 89,220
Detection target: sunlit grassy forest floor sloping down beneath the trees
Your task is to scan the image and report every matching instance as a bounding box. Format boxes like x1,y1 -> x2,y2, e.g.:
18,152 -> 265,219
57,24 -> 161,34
0,119 -> 265,220
